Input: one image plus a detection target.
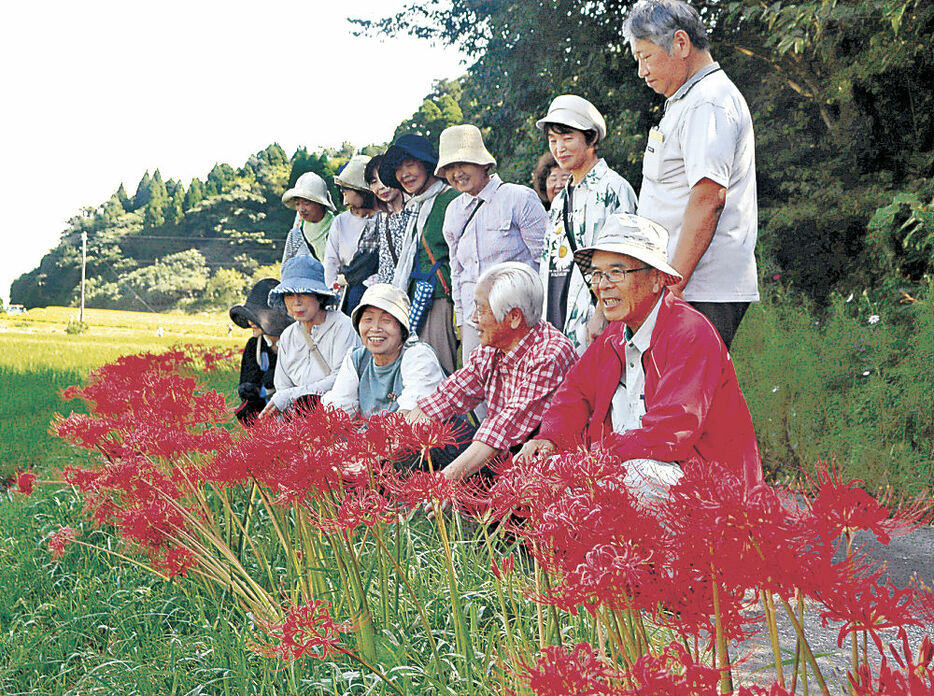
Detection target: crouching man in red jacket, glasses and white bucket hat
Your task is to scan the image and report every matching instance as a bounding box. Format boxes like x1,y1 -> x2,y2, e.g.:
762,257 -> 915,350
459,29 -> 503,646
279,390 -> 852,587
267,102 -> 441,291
519,214 -> 762,497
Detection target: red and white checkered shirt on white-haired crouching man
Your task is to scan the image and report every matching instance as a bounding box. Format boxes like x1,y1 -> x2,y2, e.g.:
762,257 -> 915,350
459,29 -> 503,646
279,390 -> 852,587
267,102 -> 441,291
418,321 -> 577,450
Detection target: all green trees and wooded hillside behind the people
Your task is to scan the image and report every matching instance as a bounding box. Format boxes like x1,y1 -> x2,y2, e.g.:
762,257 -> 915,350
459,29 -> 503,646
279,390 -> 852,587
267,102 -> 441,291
11,0 -> 934,309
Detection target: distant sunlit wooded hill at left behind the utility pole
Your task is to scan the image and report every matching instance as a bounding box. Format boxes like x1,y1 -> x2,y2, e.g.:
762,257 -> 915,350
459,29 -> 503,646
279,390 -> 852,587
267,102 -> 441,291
10,144 -> 339,311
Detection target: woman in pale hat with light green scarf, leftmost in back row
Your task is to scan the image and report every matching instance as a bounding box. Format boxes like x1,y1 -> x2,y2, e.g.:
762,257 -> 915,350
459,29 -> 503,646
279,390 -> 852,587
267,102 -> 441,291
282,172 -> 336,263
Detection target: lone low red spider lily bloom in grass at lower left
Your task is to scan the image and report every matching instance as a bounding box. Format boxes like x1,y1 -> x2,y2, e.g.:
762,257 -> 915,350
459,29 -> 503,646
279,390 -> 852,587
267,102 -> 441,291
253,600 -> 354,662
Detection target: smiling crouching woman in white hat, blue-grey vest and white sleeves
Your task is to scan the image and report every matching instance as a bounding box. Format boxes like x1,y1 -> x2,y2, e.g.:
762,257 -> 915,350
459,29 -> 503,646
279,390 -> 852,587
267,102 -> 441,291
321,283 -> 444,418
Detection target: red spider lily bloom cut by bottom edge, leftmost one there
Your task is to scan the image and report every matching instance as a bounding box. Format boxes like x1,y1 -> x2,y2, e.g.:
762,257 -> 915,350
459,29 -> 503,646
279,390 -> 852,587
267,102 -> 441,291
521,643 -> 624,696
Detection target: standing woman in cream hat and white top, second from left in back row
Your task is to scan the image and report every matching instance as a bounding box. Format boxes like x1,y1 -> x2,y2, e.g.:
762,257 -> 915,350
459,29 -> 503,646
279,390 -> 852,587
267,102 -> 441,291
323,155 -> 379,314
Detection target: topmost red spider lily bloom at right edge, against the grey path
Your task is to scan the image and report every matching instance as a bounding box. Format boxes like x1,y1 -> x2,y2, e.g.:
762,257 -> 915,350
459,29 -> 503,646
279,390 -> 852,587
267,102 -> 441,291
810,465 -> 932,544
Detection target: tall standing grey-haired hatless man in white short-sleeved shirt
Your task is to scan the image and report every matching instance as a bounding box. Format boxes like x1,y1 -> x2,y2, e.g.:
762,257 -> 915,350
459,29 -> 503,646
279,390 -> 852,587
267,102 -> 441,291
623,0 -> 759,347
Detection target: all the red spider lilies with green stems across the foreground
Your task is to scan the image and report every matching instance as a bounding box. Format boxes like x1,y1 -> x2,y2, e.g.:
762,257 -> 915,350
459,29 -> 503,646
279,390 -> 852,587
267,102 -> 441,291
40,350 -> 934,696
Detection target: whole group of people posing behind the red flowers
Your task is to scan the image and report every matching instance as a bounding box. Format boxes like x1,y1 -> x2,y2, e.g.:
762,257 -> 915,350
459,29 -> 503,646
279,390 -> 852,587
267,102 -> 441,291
231,0 -> 762,497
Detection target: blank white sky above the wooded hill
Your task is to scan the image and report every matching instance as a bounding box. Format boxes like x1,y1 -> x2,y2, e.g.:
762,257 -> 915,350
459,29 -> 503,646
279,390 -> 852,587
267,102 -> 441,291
0,0 -> 467,302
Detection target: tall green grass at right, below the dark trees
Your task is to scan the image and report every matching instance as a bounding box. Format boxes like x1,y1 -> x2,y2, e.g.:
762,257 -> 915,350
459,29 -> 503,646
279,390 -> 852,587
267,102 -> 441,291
733,280 -> 934,492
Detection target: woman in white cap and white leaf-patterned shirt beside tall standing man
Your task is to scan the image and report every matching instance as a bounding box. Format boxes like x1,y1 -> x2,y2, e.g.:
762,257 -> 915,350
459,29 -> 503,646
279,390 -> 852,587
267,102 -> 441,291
535,94 -> 637,353
